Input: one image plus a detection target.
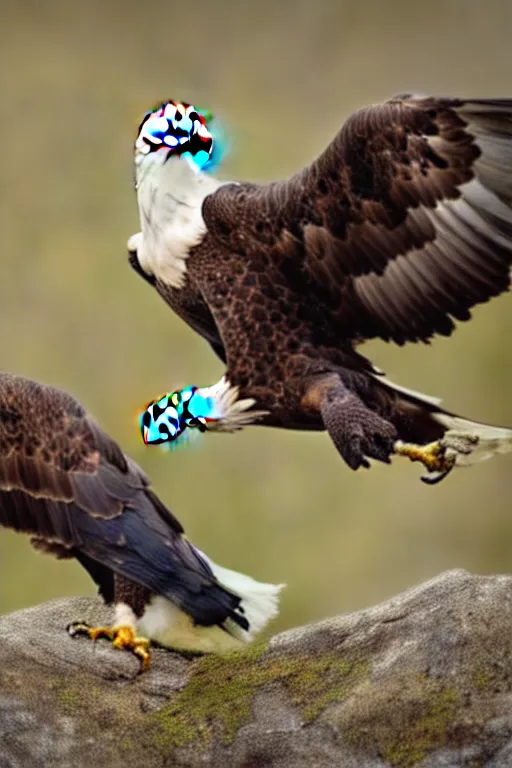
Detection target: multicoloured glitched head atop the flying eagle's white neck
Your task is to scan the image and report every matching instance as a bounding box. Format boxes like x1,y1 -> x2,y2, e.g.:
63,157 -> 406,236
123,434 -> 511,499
135,101 -> 220,171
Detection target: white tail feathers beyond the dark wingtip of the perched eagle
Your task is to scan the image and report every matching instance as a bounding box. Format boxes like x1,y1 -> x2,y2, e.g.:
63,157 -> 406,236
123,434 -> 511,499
201,552 -> 286,643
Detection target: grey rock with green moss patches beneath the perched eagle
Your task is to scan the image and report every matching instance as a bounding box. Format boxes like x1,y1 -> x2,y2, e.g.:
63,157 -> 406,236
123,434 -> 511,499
0,571 -> 512,768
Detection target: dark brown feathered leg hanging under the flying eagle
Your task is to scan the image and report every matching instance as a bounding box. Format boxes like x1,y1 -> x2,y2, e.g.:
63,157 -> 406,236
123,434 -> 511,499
310,375 -> 398,469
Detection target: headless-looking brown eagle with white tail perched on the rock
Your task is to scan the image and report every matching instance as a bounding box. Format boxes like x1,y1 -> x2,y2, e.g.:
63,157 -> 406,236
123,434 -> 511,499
0,373 -> 282,666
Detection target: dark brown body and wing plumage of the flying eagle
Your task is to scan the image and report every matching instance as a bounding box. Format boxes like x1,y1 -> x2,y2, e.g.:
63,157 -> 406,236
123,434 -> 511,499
133,96 -> 512,465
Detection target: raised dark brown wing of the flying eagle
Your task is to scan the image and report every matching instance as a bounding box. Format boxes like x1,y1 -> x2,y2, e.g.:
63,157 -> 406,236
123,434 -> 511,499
203,96 -> 512,344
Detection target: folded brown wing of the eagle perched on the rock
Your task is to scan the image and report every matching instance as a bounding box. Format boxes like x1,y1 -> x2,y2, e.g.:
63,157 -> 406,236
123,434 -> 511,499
0,373 -> 245,624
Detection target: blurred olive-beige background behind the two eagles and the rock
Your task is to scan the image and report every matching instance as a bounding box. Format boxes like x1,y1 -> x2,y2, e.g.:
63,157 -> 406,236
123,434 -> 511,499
0,0 -> 512,629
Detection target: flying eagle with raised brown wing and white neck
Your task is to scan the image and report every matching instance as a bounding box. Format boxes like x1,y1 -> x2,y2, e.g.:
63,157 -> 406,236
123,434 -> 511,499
128,96 -> 512,479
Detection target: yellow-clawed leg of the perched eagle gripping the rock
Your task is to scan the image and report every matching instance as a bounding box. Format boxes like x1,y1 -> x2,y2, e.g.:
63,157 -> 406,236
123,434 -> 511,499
67,574 -> 151,672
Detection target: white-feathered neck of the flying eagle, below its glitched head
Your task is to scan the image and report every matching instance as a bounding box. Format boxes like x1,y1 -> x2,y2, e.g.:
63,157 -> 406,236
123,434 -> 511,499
133,152 -> 227,288
